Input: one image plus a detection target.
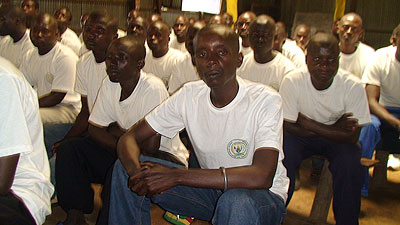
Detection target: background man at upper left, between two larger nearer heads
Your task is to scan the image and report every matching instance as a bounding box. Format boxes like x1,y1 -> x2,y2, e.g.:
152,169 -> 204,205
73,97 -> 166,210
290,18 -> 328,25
54,7 -> 82,55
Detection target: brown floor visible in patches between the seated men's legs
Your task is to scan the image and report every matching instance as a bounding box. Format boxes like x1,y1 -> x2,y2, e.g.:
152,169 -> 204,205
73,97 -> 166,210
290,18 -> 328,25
44,160 -> 400,225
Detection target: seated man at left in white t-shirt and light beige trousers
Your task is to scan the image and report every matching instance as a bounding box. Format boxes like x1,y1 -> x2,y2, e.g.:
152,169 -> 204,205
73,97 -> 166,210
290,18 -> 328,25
21,13 -> 80,156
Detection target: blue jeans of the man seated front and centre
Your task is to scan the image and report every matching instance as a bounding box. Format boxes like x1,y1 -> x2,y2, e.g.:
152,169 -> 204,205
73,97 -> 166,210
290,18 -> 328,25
109,157 -> 286,225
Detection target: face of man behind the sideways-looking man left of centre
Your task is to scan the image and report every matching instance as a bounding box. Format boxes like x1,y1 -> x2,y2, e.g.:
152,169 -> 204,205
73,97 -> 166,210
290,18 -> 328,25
83,16 -> 115,52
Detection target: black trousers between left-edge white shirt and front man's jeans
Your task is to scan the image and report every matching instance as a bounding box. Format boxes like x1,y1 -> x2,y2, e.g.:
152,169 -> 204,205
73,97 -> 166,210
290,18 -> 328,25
56,137 -> 117,214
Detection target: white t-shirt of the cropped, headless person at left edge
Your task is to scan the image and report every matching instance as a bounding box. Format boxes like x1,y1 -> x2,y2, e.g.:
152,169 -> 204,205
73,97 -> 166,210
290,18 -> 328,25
0,57 -> 54,224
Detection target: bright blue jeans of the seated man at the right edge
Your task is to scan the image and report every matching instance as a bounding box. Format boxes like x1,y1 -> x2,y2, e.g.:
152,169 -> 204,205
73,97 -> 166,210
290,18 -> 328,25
359,107 -> 400,196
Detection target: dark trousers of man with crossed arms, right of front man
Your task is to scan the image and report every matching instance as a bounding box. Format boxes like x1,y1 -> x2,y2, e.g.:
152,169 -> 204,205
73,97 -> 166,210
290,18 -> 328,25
283,135 -> 364,225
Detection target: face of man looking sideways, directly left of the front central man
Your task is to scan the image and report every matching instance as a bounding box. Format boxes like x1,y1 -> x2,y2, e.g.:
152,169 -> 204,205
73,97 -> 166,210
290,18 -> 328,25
106,40 -> 139,83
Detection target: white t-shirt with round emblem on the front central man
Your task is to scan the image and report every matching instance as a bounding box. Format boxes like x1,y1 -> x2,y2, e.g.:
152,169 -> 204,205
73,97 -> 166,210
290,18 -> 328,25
146,77 -> 289,201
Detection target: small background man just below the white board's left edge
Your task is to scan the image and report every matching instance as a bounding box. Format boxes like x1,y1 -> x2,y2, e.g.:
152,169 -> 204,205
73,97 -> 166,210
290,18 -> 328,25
169,15 -> 189,53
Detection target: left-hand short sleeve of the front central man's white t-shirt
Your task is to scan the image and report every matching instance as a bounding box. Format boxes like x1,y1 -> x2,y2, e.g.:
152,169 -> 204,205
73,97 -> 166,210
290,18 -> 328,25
145,88 -> 186,138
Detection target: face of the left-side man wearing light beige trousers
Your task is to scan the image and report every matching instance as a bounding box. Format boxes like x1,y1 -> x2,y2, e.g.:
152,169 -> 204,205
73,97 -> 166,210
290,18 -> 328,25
30,14 -> 59,50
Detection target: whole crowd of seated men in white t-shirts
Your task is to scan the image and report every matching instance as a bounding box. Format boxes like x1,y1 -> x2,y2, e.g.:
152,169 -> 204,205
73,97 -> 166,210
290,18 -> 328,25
0,0 -> 400,225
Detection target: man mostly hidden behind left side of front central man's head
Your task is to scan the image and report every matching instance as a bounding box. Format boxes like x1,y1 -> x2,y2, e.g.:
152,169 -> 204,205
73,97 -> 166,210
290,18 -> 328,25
168,21 -> 206,94
